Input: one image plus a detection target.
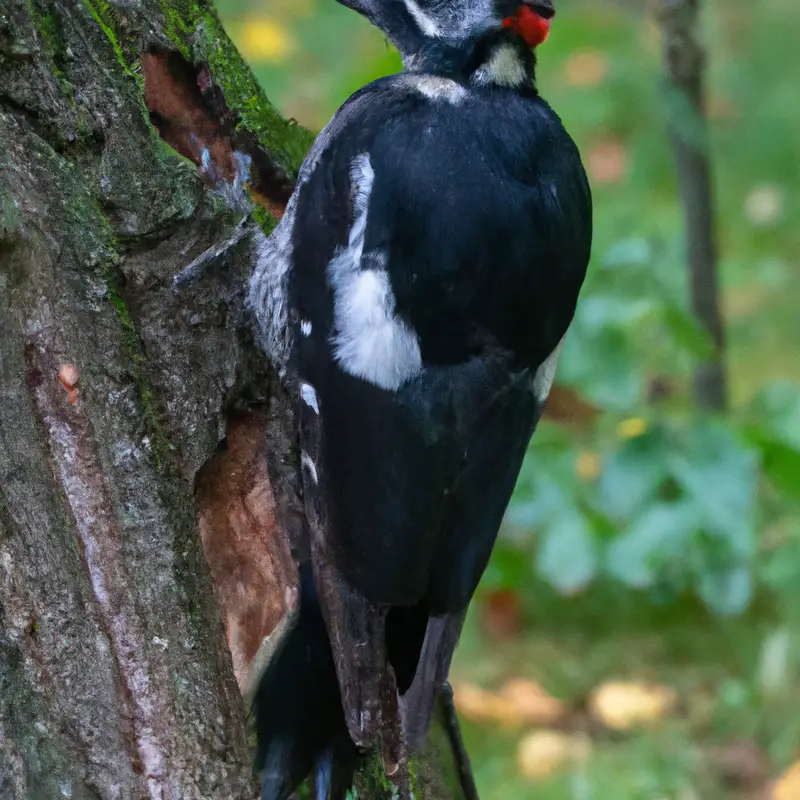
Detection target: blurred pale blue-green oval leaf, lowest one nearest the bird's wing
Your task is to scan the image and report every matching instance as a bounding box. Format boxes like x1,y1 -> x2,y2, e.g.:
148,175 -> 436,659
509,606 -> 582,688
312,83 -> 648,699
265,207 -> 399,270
537,511 -> 598,594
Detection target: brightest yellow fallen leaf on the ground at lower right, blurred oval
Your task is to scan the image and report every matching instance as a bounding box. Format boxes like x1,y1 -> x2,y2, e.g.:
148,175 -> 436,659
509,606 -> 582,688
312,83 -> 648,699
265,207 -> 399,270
589,681 -> 678,731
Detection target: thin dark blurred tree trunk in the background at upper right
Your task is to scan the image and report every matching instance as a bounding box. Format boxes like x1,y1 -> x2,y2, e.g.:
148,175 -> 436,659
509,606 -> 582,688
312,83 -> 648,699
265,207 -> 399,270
657,0 -> 727,411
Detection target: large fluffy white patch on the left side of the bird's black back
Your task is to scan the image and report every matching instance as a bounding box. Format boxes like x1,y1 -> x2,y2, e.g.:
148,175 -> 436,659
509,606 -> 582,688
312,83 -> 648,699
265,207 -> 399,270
328,153 -> 422,390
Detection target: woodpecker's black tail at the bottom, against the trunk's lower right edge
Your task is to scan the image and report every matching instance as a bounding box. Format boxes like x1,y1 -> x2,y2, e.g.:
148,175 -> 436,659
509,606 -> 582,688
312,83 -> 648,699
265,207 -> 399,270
253,566 -> 346,800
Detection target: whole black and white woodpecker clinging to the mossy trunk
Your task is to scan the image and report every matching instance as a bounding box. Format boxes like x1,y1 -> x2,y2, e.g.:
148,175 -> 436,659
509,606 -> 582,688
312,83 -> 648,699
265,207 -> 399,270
250,0 -> 592,800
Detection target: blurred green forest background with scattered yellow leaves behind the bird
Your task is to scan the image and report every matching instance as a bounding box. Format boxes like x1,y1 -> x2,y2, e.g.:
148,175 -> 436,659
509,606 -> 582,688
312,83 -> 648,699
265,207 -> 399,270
212,0 -> 800,800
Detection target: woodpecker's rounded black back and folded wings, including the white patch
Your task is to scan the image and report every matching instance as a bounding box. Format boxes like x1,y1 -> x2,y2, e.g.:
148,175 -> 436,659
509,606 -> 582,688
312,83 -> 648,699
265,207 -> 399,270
292,76 -> 591,612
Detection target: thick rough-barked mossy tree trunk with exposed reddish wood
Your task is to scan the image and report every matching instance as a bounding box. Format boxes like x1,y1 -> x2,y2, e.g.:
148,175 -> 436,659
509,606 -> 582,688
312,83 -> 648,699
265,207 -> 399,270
0,0 -> 472,800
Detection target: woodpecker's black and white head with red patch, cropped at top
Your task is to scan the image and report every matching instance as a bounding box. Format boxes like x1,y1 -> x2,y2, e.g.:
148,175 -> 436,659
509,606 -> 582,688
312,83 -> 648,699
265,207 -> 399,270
339,0 -> 555,59
